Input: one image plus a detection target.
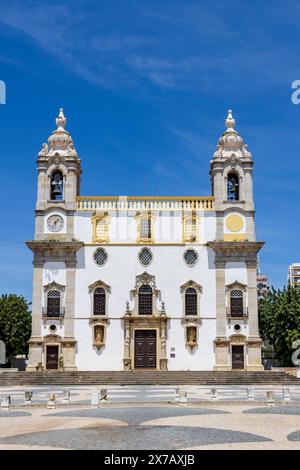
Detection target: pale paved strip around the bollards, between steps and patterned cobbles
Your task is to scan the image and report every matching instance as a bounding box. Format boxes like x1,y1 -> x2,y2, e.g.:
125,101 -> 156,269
0,385 -> 300,405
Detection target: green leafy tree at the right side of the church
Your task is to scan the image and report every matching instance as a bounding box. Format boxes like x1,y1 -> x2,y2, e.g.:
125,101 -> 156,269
259,285 -> 300,366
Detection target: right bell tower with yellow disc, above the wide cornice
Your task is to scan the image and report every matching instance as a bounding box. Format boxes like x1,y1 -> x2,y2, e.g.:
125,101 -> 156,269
210,110 -> 255,241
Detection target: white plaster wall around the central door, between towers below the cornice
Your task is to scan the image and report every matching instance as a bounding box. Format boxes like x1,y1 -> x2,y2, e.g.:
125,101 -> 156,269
75,246 -> 216,370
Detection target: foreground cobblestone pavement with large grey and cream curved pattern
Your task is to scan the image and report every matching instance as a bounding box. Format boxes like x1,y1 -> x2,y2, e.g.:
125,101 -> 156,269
0,403 -> 300,450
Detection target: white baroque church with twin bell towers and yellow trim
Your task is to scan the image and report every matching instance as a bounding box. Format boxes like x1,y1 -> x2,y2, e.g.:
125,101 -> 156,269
27,109 -> 263,371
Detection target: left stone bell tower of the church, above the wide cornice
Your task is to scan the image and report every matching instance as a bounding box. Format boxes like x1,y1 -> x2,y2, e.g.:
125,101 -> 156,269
35,108 -> 82,240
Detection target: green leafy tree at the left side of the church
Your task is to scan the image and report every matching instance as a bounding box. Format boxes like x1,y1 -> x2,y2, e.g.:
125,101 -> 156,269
0,294 -> 31,359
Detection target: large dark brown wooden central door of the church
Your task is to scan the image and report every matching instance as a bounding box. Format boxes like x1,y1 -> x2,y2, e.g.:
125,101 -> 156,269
134,330 -> 156,369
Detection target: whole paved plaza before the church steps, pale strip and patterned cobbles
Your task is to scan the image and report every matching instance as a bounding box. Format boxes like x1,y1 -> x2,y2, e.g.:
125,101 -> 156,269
0,386 -> 300,451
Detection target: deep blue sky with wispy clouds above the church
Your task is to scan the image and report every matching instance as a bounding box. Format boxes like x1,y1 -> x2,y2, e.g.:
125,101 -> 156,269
0,0 -> 300,299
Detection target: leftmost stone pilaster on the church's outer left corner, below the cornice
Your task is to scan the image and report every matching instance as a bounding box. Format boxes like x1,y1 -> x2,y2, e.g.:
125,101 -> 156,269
27,255 -> 44,371
